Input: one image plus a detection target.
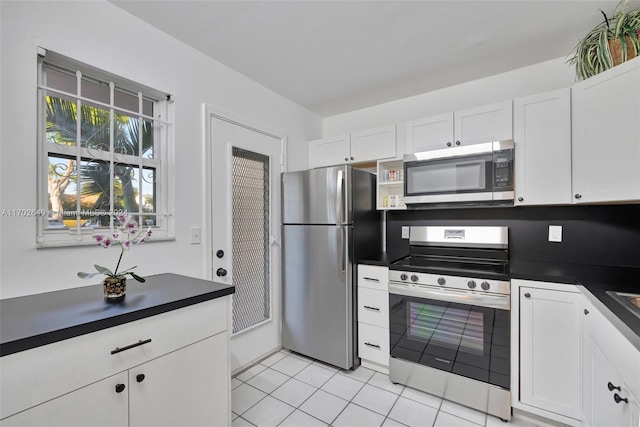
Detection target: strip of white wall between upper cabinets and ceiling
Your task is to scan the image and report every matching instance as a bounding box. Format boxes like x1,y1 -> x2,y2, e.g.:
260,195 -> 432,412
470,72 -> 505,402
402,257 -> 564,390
324,58 -> 575,137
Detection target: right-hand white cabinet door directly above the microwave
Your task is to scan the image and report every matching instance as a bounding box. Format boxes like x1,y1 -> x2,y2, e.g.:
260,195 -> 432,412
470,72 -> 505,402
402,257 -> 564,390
453,101 -> 513,145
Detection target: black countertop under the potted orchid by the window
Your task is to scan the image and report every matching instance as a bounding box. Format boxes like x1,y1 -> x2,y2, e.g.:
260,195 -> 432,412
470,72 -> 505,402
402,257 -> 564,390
0,273 -> 235,356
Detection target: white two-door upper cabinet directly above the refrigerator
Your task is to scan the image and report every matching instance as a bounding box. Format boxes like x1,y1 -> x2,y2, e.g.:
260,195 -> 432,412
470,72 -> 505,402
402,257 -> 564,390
308,125 -> 396,169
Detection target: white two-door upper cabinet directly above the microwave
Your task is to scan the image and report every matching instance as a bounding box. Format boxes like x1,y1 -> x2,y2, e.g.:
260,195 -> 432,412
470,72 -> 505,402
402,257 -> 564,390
406,100 -> 513,153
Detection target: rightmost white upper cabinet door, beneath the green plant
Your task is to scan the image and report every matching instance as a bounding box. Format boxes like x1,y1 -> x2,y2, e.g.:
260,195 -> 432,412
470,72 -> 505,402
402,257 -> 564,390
572,58 -> 640,203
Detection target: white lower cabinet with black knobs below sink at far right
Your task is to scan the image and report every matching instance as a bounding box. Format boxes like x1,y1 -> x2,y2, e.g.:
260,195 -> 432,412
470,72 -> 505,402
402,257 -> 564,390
582,300 -> 640,427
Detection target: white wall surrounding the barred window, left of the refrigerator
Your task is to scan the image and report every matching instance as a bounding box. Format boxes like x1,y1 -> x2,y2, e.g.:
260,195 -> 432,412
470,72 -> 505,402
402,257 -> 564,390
0,1 -> 322,298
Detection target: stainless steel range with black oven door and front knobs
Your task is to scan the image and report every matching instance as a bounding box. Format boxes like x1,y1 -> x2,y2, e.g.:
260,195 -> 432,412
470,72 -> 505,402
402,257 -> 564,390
389,226 -> 511,420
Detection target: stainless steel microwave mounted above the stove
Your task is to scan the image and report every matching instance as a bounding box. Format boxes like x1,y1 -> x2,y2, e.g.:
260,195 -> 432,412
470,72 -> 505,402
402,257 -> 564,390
403,140 -> 514,209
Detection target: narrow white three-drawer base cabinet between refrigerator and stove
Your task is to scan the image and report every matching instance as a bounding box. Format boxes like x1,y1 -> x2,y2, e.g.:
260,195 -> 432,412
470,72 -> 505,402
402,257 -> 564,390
358,264 -> 389,373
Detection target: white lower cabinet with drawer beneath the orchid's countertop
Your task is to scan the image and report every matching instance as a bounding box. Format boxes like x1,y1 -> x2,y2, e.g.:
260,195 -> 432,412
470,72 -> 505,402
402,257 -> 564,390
0,297 -> 231,427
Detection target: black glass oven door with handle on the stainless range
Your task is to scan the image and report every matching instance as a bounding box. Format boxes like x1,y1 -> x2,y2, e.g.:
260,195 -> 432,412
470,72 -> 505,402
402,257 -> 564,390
389,284 -> 510,389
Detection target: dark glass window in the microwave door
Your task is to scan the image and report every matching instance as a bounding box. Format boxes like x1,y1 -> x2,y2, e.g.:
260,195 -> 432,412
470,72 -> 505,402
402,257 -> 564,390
406,155 -> 492,195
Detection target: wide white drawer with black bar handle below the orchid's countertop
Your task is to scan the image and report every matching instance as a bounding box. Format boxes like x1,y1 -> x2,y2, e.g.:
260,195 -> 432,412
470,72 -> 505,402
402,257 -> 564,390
0,297 -> 228,418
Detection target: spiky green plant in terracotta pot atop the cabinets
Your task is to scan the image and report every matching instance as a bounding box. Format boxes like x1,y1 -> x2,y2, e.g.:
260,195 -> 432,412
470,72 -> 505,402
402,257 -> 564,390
568,0 -> 640,80
